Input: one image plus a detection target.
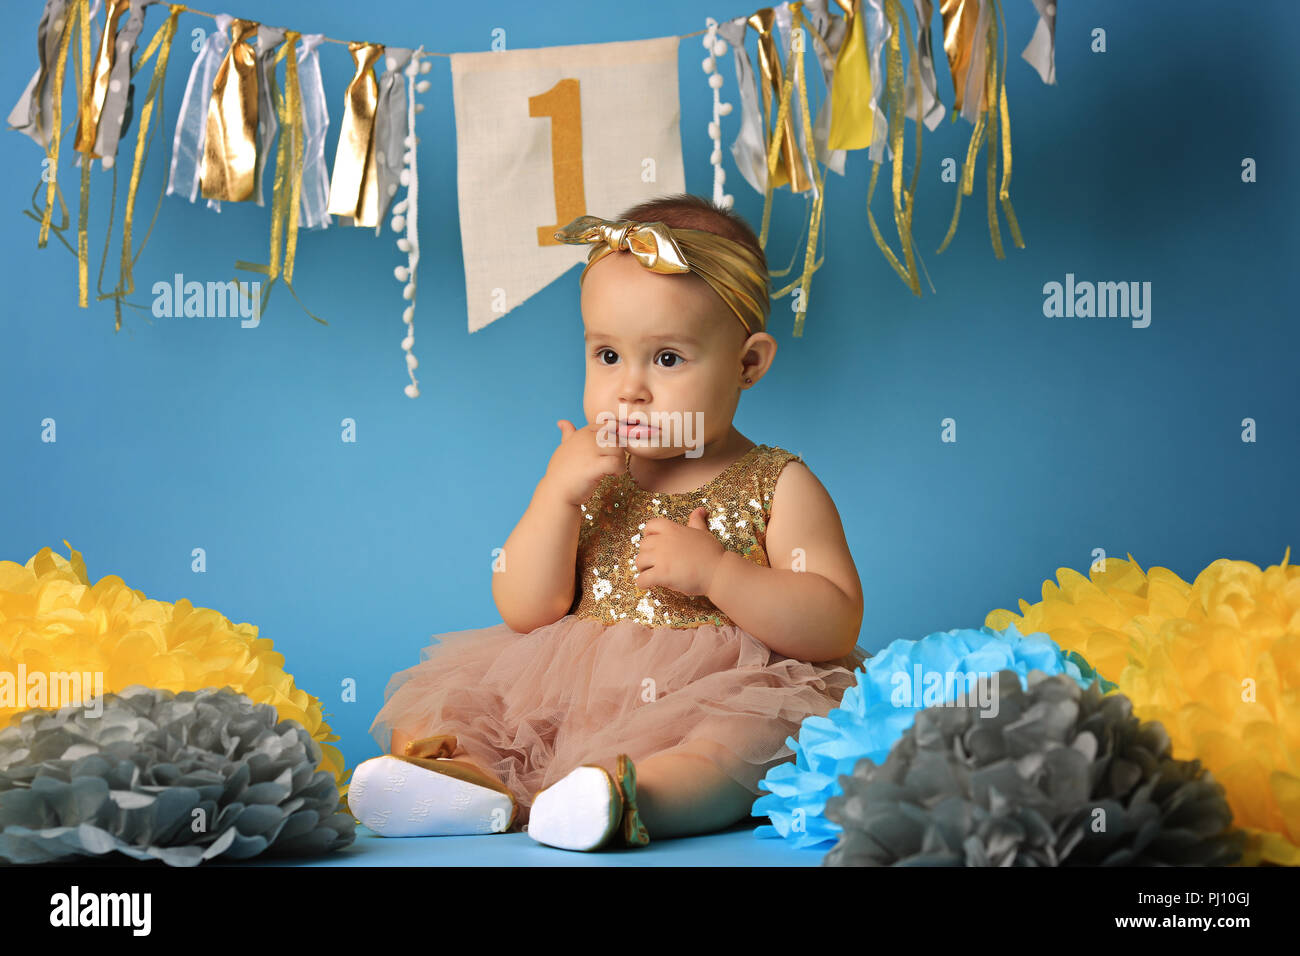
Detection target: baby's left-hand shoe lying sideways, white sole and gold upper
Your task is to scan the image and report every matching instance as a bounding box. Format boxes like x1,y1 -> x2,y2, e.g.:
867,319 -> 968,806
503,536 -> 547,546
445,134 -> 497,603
347,754 -> 516,836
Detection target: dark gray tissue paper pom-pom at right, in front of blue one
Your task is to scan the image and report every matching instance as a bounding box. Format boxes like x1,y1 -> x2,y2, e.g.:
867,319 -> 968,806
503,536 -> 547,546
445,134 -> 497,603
822,671 -> 1245,866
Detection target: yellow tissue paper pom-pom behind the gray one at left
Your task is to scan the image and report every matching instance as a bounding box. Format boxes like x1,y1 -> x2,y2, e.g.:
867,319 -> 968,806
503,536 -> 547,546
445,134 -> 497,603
0,541 -> 345,793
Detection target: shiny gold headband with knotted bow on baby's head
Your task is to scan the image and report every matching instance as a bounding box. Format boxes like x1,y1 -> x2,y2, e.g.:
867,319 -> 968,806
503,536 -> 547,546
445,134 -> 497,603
555,216 -> 771,334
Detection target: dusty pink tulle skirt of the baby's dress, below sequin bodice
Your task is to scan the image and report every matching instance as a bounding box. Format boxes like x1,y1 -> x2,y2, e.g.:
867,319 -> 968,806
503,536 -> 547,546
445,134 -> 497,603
371,615 -> 866,826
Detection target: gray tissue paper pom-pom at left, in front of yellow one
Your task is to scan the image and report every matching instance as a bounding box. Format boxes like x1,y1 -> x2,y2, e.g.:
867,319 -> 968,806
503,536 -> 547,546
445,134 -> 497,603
0,685 -> 356,866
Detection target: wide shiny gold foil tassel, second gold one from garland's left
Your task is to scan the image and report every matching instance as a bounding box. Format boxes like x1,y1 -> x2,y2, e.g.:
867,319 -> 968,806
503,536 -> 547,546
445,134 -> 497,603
199,20 -> 257,203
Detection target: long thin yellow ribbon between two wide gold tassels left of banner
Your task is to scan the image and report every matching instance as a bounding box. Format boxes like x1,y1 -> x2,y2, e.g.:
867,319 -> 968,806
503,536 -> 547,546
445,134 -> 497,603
235,30 -> 321,325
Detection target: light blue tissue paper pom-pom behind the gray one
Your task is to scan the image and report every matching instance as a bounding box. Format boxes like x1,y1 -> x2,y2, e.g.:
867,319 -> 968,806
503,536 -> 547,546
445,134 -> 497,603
750,624 -> 1117,847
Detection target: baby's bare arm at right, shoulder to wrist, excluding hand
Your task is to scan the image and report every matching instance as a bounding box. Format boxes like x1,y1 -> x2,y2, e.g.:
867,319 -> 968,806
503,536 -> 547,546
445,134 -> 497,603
707,462 -> 863,662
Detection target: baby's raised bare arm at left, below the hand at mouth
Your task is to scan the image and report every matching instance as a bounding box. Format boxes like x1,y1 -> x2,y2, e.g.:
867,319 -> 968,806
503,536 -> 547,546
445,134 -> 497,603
491,477 -> 582,633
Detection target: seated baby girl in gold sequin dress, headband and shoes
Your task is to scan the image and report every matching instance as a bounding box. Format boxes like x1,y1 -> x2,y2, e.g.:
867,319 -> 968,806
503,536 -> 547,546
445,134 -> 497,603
347,195 -> 865,851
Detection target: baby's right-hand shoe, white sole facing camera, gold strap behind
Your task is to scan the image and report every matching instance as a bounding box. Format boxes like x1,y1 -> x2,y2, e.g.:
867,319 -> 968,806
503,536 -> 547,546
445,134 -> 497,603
528,753 -> 650,851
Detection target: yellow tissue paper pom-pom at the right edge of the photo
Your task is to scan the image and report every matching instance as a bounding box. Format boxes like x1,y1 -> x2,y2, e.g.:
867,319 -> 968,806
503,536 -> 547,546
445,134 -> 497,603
984,548 -> 1300,866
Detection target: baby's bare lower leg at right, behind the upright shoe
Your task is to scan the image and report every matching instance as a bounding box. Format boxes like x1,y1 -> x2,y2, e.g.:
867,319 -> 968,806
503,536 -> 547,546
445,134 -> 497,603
624,741 -> 758,843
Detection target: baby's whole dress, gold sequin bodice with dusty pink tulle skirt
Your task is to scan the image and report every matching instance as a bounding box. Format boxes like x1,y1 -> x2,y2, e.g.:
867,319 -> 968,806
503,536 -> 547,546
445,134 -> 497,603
371,445 -> 866,826
